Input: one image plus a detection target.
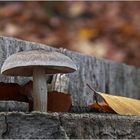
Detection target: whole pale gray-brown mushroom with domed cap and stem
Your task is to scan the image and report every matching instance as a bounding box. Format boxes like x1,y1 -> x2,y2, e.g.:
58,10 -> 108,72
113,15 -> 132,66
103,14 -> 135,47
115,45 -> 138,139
1,50 -> 77,112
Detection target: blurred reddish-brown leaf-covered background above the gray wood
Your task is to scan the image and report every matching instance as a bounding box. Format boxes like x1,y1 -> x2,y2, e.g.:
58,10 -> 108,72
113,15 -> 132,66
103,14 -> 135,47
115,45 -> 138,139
0,1 -> 140,67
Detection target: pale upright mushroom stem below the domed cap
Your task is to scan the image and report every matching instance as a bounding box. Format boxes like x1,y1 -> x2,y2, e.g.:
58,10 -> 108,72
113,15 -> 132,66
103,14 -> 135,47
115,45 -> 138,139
33,68 -> 47,112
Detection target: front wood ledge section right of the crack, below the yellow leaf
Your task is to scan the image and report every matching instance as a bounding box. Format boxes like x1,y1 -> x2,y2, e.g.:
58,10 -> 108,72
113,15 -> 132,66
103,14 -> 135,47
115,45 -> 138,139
60,114 -> 140,139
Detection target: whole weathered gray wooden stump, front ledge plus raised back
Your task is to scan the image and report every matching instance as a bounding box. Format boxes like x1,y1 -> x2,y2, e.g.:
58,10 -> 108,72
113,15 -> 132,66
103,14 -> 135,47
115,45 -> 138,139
0,37 -> 140,139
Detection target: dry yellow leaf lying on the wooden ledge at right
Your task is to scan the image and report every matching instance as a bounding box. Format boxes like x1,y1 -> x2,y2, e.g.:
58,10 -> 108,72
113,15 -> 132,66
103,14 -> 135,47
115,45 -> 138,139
90,92 -> 140,115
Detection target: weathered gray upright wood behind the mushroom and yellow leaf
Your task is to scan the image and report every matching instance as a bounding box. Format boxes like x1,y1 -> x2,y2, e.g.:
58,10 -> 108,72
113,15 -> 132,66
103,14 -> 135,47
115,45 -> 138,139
0,37 -> 140,106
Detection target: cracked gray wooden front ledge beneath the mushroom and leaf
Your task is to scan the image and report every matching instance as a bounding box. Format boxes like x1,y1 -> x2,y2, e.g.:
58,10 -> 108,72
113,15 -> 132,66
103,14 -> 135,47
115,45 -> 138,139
0,113 -> 140,139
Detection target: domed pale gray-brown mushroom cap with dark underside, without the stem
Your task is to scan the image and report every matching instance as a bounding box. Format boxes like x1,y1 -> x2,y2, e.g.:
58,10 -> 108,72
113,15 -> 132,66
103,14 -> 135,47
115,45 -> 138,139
1,50 -> 77,76
